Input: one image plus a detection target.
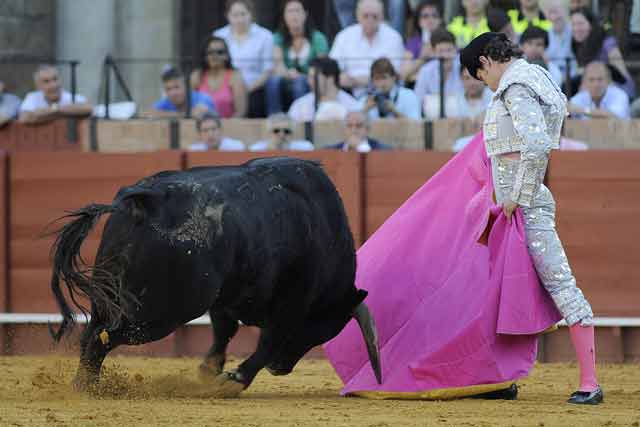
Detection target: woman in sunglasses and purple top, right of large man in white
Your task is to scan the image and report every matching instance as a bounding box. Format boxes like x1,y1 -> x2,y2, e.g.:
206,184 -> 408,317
400,0 -> 442,86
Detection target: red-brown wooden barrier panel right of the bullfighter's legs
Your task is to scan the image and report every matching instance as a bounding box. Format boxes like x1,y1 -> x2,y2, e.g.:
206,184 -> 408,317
548,151 -> 640,316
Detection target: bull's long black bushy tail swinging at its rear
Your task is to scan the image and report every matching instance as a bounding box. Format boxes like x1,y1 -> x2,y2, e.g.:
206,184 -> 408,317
49,204 -> 128,342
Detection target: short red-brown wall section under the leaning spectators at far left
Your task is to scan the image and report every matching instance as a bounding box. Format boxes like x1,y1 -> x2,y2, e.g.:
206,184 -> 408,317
0,119 -> 88,152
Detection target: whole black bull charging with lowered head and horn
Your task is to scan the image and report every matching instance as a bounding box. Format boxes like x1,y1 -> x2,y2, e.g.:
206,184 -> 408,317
51,158 -> 381,396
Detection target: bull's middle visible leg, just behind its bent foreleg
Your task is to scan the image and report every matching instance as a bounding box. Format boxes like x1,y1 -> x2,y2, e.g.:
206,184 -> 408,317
199,309 -> 238,379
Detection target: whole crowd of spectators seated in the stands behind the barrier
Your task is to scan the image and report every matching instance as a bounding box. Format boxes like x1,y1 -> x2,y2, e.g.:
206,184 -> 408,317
0,0 -> 640,152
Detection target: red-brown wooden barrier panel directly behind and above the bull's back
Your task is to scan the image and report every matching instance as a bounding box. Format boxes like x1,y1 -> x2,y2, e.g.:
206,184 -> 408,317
186,151 -> 364,245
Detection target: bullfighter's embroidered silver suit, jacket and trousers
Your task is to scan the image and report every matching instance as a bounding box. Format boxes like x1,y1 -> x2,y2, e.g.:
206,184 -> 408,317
483,59 -> 593,325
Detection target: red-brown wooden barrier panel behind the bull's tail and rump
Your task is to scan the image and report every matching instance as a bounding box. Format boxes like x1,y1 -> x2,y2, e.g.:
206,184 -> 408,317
9,152 -> 182,313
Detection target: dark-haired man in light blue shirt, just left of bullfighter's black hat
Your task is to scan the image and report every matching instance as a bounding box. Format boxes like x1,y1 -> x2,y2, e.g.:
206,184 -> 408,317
415,29 -> 464,101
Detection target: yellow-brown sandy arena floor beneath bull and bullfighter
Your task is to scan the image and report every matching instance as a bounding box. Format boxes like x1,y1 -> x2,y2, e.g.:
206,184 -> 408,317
0,357 -> 640,427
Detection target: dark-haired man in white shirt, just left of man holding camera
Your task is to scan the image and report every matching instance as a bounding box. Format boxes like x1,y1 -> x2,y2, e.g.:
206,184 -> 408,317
289,57 -> 359,122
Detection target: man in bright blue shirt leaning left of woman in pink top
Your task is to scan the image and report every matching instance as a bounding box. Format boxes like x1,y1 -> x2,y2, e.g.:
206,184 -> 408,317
144,67 -> 216,117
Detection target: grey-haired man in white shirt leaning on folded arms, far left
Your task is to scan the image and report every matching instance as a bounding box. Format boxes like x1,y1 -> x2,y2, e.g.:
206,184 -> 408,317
19,65 -> 93,124
